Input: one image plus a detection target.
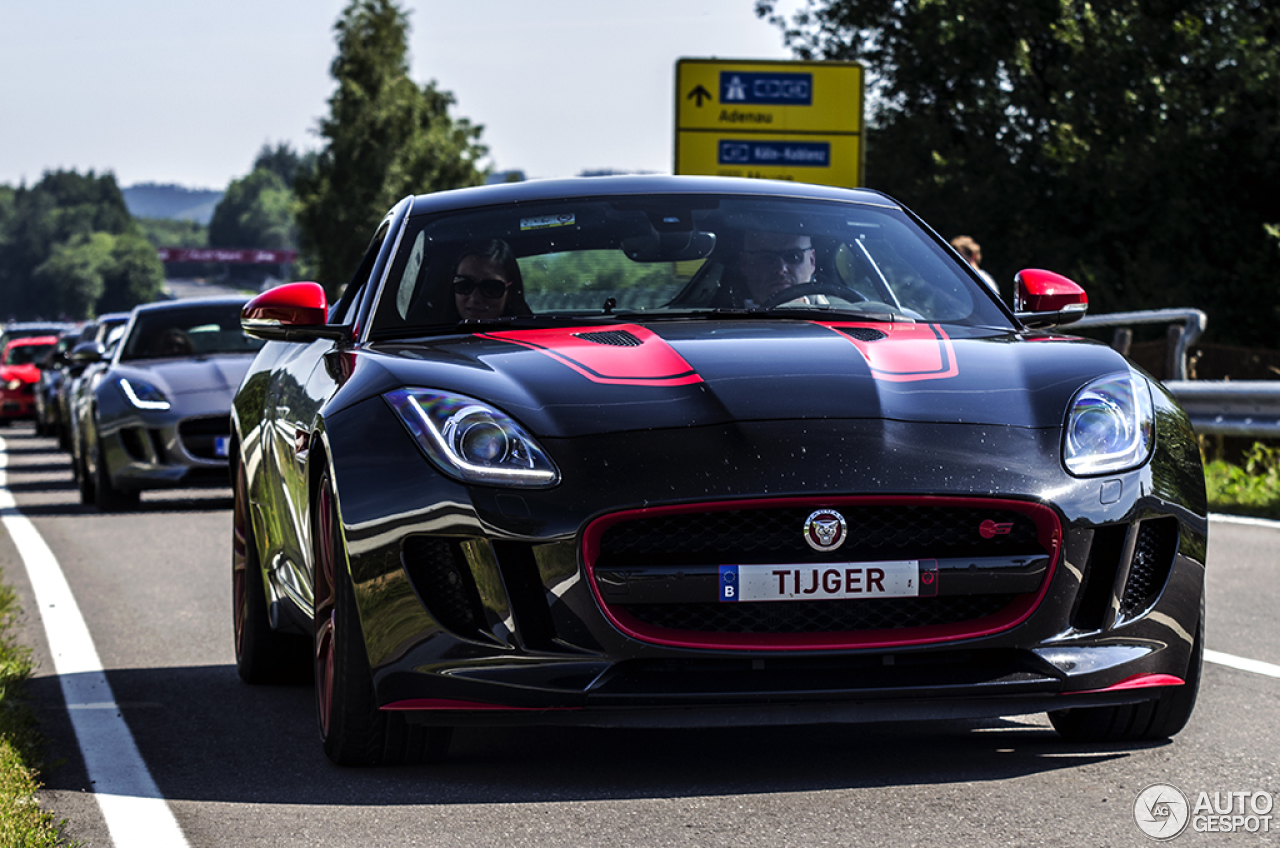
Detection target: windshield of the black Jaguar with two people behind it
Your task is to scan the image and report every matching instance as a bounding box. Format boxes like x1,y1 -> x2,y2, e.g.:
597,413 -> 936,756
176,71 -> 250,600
371,195 -> 1009,338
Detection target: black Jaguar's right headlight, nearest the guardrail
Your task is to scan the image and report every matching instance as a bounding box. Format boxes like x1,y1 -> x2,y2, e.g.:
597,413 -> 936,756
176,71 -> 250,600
1062,371 -> 1156,477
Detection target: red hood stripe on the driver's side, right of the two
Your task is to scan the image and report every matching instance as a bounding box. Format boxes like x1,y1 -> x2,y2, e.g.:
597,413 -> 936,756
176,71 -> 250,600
815,322 -> 960,382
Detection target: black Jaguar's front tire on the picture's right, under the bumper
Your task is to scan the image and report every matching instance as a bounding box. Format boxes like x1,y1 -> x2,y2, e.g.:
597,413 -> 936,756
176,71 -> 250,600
1048,612 -> 1204,742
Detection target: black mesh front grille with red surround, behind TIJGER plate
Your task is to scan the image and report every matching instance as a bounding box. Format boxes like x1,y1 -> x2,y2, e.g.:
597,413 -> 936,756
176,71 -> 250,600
584,497 -> 1061,647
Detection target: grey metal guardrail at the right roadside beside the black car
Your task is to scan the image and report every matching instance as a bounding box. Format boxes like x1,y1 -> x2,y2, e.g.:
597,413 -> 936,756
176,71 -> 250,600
1073,309 -> 1280,438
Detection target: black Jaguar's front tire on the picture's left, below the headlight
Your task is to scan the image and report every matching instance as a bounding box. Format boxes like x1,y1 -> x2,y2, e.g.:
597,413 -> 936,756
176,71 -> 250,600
312,474 -> 452,766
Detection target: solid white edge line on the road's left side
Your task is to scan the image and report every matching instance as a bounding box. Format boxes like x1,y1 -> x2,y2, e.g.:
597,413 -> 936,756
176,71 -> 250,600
0,438 -> 187,848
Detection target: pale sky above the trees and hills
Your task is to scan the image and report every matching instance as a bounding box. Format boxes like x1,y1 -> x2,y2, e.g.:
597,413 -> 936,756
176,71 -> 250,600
0,0 -> 800,190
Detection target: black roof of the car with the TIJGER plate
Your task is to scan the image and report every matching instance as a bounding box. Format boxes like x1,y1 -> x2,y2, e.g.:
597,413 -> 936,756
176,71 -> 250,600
412,174 -> 900,215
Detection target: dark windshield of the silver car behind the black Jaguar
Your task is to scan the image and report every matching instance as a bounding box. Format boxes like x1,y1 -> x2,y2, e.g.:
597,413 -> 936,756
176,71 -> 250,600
120,302 -> 264,361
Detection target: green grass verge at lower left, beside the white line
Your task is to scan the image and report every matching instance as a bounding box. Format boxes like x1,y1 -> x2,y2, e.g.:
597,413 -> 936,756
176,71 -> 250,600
0,573 -> 73,848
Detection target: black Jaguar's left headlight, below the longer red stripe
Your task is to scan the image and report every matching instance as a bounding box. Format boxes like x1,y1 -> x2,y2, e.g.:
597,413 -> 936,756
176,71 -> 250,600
383,388 -> 559,488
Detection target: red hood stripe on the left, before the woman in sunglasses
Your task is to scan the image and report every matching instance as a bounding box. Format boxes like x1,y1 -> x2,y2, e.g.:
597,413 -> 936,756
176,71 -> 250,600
476,324 -> 703,386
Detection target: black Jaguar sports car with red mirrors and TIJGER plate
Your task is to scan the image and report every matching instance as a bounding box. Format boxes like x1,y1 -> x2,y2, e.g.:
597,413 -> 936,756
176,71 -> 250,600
232,177 -> 1207,765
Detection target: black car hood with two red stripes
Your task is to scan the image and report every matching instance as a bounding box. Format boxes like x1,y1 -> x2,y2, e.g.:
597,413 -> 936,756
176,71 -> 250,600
349,320 -> 1129,437
